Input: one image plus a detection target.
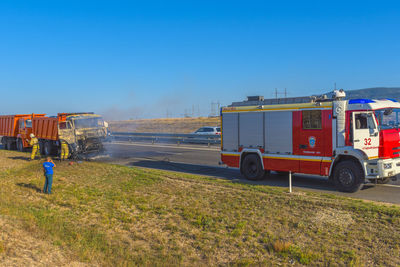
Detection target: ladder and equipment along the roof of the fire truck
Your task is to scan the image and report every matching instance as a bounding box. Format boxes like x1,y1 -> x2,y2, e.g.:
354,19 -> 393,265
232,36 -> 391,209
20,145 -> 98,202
229,89 -> 346,107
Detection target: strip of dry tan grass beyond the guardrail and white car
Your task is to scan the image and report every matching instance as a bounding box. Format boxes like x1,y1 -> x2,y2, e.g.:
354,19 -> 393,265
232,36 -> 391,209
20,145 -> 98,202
109,117 -> 220,133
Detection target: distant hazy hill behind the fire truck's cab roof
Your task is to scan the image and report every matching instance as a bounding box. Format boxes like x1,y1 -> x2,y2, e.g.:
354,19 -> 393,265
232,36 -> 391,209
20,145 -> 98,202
345,87 -> 400,101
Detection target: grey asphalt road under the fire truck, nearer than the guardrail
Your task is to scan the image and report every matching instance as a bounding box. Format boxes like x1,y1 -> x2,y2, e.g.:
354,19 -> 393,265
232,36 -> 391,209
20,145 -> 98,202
103,142 -> 400,204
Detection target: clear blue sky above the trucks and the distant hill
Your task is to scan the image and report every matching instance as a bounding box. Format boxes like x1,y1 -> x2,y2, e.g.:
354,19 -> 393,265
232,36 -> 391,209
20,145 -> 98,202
0,0 -> 400,119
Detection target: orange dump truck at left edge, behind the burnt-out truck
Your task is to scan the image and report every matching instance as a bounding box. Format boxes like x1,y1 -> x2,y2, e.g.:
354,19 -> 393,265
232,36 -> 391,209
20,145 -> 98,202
0,114 -> 45,151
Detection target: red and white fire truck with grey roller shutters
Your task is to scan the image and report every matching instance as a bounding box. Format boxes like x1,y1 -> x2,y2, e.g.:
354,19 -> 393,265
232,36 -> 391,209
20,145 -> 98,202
221,90 -> 400,192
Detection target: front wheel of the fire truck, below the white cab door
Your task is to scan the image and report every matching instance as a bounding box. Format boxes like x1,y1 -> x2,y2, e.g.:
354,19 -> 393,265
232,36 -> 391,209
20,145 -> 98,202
333,160 -> 364,193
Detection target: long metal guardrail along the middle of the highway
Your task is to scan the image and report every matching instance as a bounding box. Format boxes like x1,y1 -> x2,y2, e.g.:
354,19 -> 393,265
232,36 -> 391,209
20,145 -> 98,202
110,132 -> 221,146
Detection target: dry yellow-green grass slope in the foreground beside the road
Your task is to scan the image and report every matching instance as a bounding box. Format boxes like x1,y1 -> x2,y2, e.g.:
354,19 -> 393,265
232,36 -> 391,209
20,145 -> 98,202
0,151 -> 400,266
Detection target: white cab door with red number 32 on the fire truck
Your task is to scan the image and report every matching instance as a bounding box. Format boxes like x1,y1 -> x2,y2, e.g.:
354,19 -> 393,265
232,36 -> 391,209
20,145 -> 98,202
352,112 -> 379,159
